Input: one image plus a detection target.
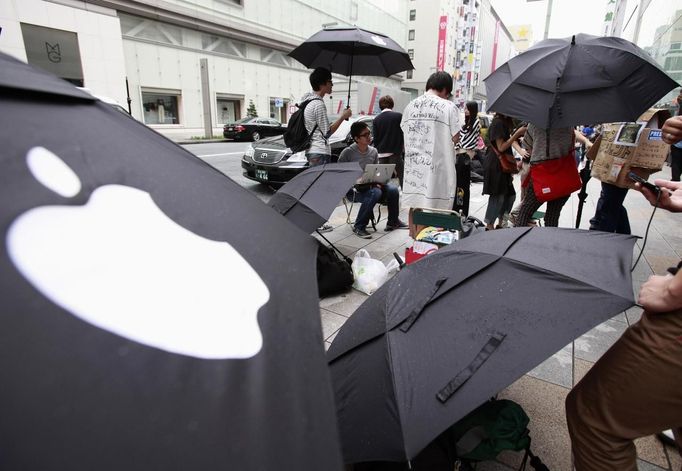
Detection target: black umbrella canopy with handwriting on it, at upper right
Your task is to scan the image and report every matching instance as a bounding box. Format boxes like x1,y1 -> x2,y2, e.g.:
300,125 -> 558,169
485,34 -> 679,129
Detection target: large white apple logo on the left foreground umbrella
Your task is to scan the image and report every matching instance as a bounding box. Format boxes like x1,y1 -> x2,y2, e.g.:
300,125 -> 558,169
7,147 -> 270,359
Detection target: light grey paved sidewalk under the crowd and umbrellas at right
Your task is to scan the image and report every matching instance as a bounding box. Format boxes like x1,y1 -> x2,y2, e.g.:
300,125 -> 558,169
320,167 -> 682,471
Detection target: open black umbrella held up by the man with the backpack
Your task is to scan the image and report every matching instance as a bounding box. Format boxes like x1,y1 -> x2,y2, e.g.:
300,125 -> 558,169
289,27 -> 414,108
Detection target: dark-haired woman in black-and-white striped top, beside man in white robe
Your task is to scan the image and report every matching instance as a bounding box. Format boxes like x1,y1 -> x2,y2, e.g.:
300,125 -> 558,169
452,101 -> 481,216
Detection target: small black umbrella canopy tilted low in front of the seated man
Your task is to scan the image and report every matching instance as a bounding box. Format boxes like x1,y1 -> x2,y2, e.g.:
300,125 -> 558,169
268,162 -> 362,234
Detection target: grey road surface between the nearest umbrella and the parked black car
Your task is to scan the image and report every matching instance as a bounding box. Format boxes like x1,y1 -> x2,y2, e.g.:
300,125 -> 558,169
182,138 -> 274,201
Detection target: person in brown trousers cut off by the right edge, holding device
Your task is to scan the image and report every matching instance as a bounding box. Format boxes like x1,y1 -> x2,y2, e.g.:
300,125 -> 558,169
566,116 -> 682,471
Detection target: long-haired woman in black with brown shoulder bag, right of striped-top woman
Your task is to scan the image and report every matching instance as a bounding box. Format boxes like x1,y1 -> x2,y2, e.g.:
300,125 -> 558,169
483,113 -> 526,229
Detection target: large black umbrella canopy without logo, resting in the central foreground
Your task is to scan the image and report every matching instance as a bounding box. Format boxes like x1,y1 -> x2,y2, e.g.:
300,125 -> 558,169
327,228 -> 635,463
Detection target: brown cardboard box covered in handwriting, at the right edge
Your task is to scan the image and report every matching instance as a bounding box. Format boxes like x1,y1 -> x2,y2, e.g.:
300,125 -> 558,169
588,109 -> 670,188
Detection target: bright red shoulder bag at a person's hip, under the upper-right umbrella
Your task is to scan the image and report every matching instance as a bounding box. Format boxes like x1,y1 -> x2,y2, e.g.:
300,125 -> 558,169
530,151 -> 582,203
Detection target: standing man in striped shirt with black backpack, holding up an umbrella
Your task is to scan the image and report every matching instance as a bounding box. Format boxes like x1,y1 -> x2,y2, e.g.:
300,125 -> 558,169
285,67 -> 353,232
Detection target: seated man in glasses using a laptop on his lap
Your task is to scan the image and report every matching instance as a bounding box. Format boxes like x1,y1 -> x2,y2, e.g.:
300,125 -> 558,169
339,122 -> 407,239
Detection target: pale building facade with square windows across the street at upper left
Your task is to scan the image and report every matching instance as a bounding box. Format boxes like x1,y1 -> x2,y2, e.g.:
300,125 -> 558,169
0,0 -> 408,139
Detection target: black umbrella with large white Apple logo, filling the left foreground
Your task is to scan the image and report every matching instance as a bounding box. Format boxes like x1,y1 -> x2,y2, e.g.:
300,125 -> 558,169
0,54 -> 341,470
